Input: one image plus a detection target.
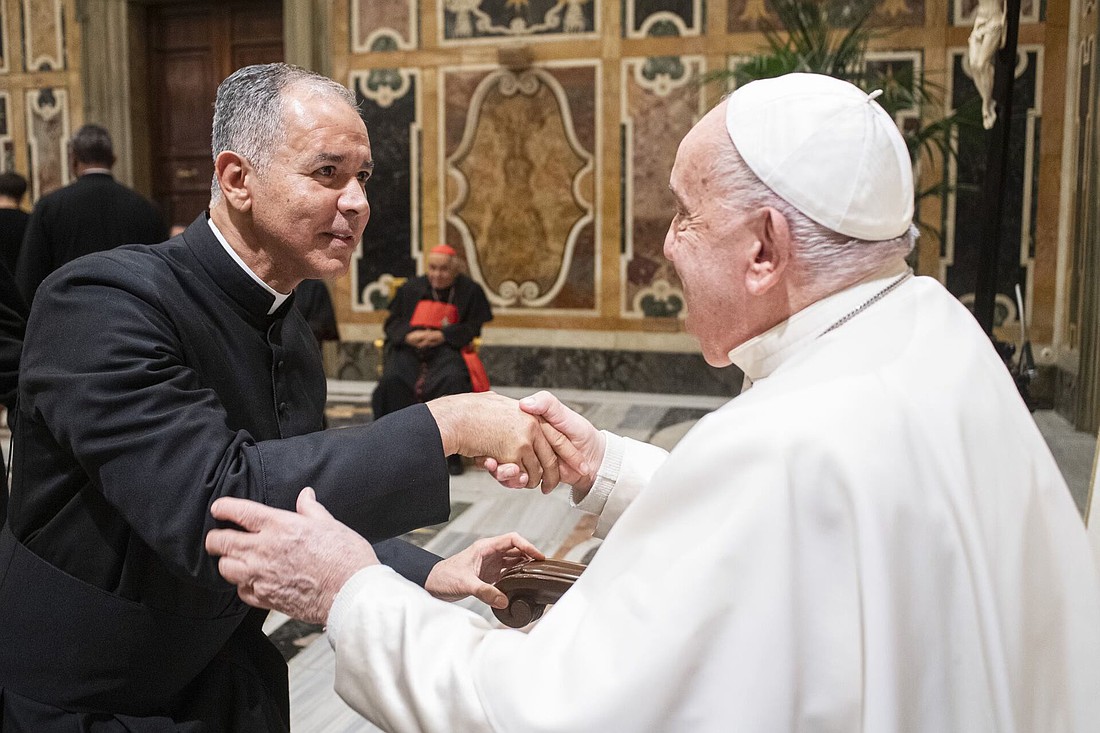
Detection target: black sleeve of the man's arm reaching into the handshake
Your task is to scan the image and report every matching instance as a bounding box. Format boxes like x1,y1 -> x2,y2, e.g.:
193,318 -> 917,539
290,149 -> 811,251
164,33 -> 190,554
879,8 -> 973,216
20,256 -> 450,586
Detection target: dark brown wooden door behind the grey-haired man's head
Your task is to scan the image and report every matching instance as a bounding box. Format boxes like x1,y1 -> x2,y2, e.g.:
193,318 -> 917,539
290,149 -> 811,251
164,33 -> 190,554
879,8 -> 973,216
146,0 -> 283,225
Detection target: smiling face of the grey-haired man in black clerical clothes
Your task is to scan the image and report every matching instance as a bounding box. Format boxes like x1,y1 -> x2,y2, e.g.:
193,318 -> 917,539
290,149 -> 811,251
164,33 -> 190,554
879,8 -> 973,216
252,85 -> 373,287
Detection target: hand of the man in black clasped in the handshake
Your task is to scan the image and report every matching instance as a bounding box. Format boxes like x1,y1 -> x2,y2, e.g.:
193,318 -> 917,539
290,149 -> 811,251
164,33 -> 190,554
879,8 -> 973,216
427,392 -> 583,492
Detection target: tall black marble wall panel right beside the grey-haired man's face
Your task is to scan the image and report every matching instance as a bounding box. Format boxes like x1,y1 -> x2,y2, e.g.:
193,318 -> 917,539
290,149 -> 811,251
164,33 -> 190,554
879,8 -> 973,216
352,69 -> 420,308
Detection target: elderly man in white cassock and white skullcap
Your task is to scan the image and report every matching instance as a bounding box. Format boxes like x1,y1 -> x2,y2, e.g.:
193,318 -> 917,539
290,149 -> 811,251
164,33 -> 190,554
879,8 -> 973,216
207,74 -> 1100,733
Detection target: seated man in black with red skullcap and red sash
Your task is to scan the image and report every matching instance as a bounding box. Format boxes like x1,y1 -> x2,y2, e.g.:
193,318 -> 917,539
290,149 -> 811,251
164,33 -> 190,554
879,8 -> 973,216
371,244 -> 493,418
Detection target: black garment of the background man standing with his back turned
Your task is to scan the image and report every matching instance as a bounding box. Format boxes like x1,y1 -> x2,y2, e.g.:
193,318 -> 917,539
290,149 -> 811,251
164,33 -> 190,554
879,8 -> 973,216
14,173 -> 168,303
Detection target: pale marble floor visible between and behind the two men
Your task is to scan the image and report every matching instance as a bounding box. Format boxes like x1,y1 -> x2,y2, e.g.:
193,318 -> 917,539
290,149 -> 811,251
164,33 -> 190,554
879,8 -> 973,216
267,382 -> 1096,733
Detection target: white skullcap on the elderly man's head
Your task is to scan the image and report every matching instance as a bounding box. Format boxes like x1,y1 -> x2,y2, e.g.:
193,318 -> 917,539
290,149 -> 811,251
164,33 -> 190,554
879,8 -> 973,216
726,74 -> 913,240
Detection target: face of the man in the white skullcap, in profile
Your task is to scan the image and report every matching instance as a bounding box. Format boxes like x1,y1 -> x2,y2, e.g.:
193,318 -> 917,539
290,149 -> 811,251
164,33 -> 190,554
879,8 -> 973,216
664,102 -> 756,367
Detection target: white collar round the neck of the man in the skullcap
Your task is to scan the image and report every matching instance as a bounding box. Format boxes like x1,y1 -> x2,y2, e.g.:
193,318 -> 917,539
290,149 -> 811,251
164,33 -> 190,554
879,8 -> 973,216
729,264 -> 910,389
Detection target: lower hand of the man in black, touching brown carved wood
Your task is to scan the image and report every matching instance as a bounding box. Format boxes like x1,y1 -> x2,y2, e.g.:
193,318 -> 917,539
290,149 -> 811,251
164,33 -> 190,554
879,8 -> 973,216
424,532 -> 546,609
